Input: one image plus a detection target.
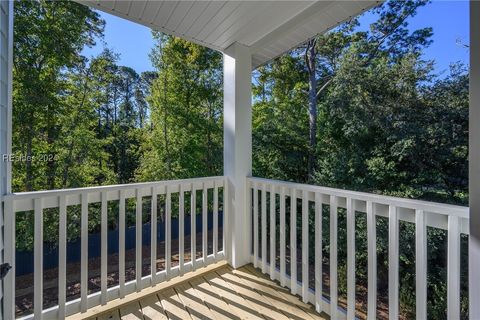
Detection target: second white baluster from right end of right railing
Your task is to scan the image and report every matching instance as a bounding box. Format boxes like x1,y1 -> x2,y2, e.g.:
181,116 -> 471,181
415,210 -> 427,319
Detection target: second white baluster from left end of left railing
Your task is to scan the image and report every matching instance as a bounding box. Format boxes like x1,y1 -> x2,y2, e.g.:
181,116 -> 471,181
58,195 -> 67,319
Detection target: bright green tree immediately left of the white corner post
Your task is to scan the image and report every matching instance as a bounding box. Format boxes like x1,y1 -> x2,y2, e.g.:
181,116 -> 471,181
137,32 -> 223,180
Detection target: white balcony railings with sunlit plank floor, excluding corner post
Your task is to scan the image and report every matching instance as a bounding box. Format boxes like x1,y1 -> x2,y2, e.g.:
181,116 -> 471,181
5,177 -> 468,319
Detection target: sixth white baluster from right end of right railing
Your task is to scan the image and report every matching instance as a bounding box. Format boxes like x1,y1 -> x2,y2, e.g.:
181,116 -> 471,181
330,196 -> 338,319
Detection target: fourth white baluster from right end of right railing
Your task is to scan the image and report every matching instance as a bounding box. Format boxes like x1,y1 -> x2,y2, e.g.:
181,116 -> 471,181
367,201 -> 377,320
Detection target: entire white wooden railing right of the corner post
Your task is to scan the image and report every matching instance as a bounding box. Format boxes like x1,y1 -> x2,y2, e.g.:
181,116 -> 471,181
248,178 -> 468,319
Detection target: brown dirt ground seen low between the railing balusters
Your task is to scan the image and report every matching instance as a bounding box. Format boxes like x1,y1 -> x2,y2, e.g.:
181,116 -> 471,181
15,230 -> 398,319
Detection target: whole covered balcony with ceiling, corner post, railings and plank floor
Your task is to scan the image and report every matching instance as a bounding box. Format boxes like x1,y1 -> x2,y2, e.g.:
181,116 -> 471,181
0,0 -> 480,320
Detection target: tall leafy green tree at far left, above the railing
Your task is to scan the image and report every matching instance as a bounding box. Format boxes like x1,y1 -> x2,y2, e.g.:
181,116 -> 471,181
13,1 -> 104,190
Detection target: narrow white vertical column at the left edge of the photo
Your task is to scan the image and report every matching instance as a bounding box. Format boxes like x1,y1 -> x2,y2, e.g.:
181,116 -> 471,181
0,1 -> 15,319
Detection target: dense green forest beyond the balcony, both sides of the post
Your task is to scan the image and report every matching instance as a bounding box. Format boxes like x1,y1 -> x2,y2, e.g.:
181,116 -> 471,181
12,0 -> 468,319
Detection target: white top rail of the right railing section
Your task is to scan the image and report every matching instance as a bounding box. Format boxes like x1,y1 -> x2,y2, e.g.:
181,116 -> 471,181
247,177 -> 469,219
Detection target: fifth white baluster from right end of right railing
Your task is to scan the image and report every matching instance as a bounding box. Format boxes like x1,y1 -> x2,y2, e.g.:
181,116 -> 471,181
347,198 -> 355,320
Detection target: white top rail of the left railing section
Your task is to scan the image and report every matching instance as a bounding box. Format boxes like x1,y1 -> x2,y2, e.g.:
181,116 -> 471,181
3,176 -> 224,200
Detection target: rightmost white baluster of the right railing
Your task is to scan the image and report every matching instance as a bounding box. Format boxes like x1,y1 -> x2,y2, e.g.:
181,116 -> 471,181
447,216 -> 460,320
